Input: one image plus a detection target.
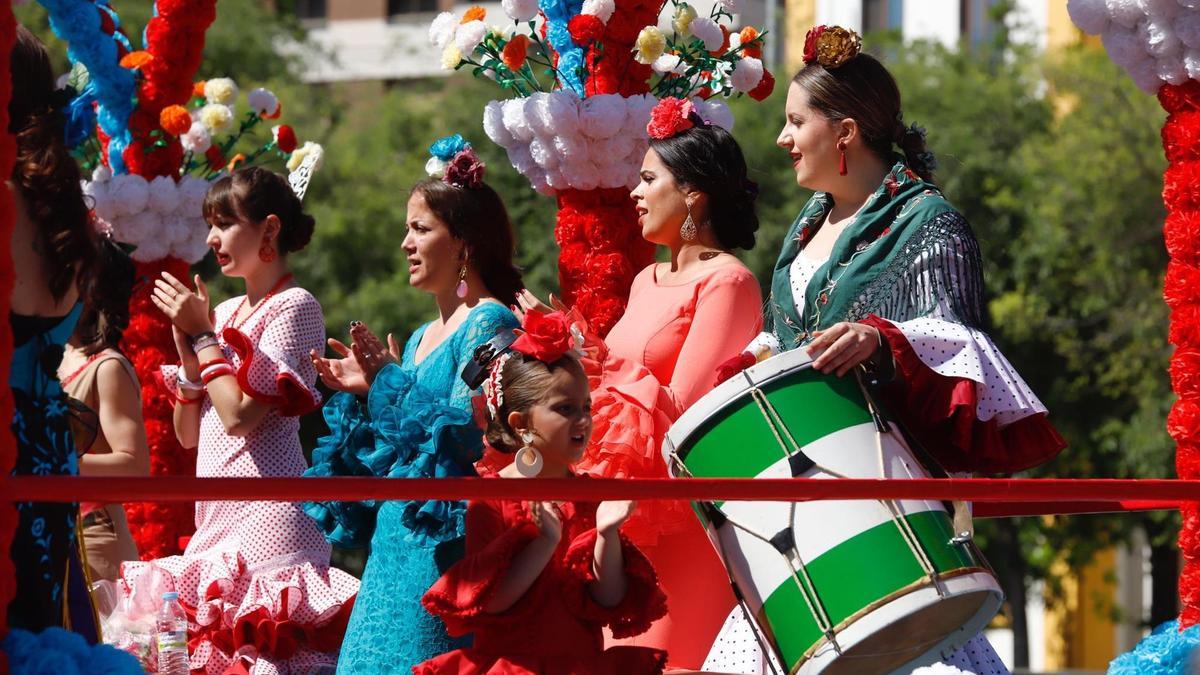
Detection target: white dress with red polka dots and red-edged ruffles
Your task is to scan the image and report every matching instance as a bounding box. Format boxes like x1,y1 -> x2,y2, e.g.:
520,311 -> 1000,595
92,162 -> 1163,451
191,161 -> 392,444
121,288 -> 359,674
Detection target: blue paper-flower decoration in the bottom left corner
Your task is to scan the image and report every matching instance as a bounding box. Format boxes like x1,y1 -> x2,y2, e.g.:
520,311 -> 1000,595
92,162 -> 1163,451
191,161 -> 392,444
0,628 -> 143,675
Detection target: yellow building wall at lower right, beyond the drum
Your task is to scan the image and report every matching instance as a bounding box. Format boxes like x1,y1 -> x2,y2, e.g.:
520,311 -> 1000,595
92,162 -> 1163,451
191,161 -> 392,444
1045,549 -> 1117,671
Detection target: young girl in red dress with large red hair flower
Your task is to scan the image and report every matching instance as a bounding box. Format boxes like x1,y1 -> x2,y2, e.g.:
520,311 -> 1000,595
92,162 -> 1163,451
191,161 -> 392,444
413,311 -> 666,675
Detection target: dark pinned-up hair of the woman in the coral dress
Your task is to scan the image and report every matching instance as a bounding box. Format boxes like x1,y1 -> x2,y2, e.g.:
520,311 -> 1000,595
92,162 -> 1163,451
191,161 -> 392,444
650,124 -> 758,251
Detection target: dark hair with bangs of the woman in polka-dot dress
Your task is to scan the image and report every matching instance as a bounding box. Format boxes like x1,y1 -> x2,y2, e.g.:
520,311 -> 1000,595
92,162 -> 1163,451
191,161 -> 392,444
204,167 -> 317,255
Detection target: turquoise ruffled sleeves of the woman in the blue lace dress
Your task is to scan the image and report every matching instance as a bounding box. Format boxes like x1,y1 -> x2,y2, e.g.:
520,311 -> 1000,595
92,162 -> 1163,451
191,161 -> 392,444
304,364 -> 482,546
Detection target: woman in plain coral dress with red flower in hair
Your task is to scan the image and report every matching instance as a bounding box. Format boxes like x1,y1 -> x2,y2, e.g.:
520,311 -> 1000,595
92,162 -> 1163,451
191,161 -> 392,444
522,98 -> 762,668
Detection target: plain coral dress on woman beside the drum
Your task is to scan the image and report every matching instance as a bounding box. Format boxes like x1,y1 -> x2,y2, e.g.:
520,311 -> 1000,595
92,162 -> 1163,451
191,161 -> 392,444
576,264 -> 762,668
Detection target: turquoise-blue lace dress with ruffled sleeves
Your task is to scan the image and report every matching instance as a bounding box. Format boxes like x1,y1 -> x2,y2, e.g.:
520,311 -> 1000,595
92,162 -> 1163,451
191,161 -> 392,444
304,303 -> 517,674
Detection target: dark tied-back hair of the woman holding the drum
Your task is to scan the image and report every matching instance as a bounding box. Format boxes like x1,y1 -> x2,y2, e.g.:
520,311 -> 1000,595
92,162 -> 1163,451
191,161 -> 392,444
792,53 -> 937,183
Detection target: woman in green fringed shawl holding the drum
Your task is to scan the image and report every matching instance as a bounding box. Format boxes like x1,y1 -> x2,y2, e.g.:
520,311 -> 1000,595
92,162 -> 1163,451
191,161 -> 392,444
706,26 -> 1064,675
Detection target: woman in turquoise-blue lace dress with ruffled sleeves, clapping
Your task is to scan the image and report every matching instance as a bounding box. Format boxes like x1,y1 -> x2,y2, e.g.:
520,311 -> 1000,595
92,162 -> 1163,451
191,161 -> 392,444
305,141 -> 521,673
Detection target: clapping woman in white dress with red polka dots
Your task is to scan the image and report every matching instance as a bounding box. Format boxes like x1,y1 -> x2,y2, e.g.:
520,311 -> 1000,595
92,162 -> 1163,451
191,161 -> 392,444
121,167 -> 359,674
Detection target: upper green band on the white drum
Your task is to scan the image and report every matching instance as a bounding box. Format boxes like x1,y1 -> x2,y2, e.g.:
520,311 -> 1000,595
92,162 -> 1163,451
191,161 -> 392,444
679,369 -> 871,478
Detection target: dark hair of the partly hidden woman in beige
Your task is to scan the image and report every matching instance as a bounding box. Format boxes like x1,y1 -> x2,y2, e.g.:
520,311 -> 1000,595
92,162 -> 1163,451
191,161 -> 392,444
74,238 -> 137,357
